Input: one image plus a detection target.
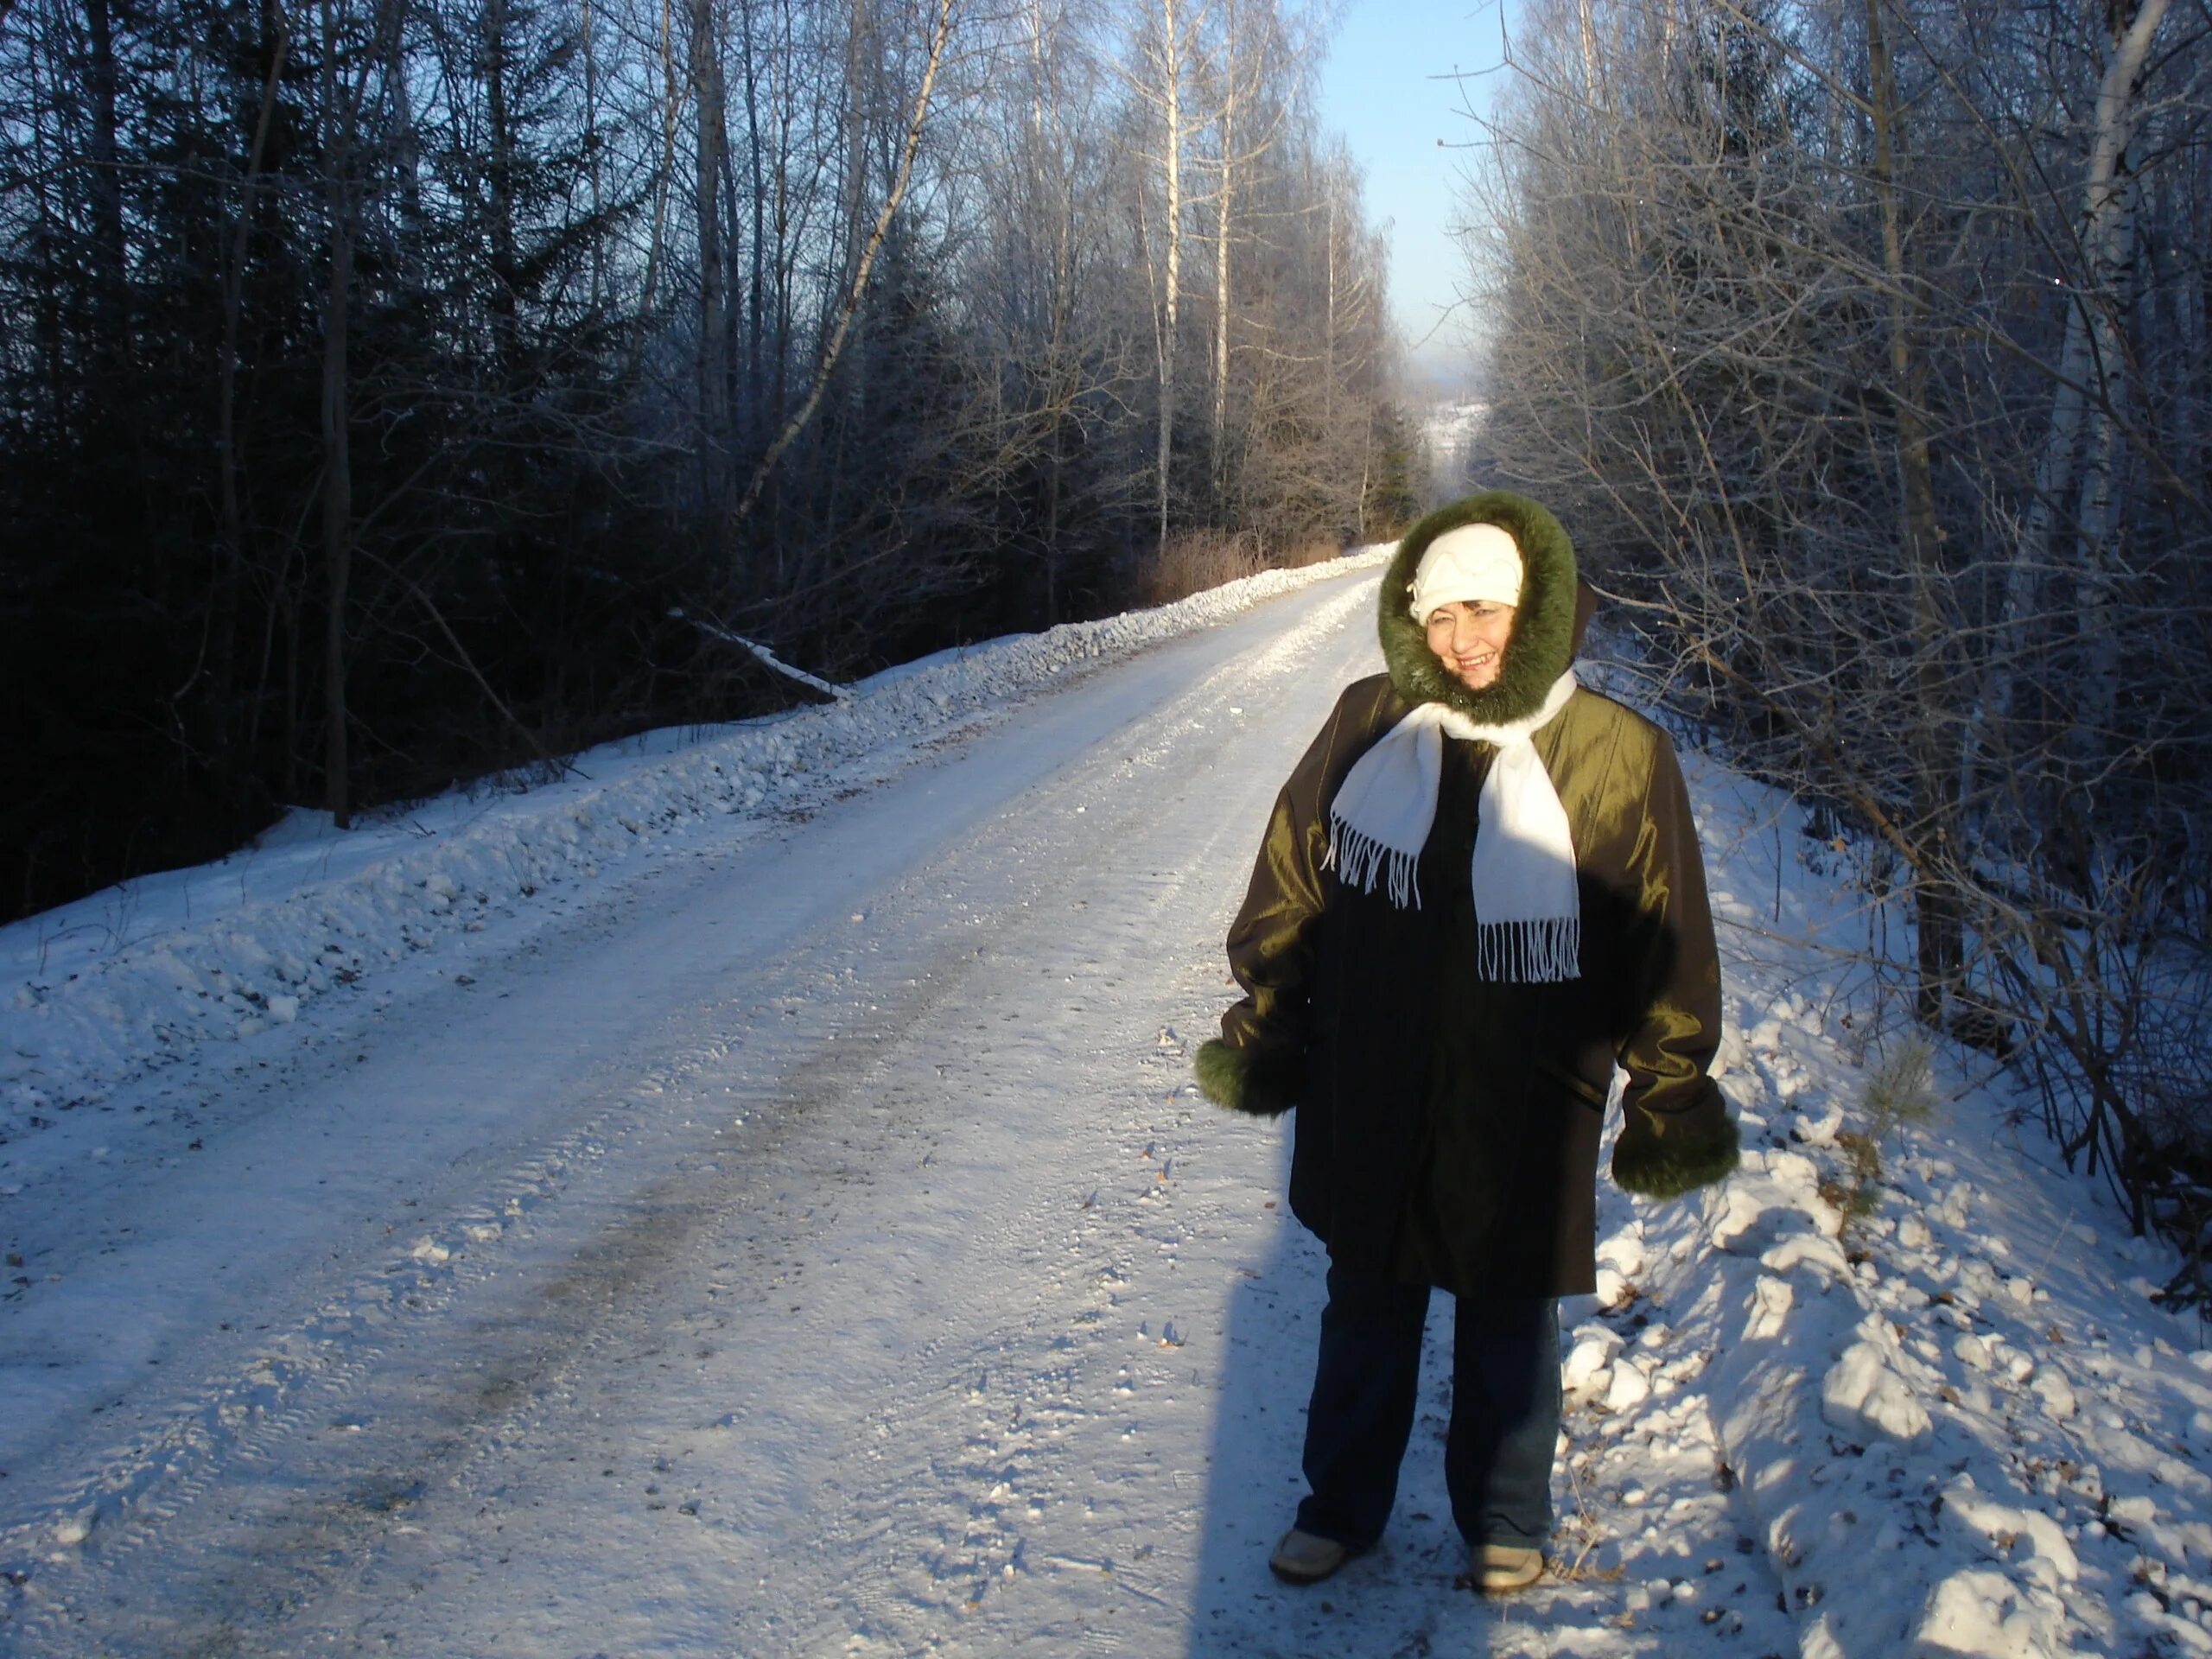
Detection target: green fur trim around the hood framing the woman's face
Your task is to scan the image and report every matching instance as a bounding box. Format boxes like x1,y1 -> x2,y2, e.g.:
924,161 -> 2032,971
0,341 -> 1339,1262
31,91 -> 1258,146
1376,489 -> 1575,726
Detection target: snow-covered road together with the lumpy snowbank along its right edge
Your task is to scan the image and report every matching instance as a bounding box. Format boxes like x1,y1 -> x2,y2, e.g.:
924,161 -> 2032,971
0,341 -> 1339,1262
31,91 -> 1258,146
0,573 -> 2212,1656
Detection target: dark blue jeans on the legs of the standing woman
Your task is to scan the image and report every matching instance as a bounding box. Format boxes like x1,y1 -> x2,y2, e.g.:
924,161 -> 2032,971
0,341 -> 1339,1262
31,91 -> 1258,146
1299,1263 -> 1560,1548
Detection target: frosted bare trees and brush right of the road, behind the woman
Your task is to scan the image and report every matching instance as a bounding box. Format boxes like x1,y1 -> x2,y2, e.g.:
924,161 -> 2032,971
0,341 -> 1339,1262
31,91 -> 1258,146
1465,0 -> 2212,1305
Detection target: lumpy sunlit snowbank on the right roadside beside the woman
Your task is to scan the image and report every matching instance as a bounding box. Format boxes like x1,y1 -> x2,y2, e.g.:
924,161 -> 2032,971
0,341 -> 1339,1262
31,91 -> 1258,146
1566,761 -> 2212,1659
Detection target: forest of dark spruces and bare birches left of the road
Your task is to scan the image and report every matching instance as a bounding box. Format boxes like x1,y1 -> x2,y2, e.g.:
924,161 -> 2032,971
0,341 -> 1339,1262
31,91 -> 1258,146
0,0 -> 1418,920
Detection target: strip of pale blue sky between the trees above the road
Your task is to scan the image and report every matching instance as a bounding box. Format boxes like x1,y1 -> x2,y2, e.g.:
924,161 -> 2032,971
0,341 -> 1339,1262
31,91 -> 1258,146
1319,0 -> 1510,393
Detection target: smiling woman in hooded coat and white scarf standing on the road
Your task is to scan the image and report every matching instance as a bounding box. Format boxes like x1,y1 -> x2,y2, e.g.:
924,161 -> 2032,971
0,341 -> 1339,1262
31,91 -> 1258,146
1197,491 -> 1737,1591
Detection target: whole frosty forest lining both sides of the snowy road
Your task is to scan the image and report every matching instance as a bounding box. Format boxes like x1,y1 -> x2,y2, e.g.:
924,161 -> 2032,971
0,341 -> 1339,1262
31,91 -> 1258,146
0,0 -> 2212,1303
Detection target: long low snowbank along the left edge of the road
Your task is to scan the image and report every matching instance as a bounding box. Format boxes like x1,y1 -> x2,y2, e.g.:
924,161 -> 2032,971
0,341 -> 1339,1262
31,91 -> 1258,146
0,546 -> 1389,1141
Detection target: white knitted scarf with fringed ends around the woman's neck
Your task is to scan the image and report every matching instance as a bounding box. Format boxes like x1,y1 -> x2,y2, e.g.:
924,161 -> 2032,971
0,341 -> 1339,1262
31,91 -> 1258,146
1323,668 -> 1581,984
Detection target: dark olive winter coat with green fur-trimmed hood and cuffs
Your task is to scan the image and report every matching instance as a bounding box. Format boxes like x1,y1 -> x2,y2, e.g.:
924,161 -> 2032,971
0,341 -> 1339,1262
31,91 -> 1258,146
1197,491 -> 1737,1299
